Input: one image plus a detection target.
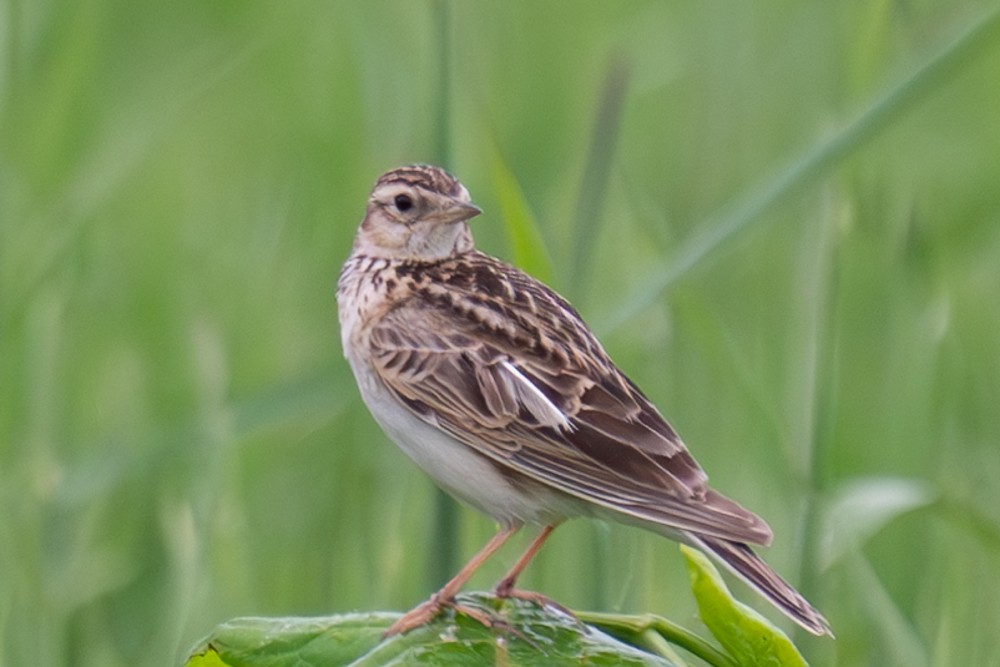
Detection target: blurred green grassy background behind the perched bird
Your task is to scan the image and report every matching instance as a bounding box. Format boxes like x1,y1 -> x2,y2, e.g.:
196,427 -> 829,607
0,0 -> 1000,666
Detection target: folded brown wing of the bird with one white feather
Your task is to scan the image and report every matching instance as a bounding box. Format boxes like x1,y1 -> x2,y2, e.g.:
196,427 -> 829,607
370,262 -> 771,544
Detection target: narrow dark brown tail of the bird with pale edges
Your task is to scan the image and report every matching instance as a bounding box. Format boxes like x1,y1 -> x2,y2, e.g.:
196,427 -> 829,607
686,533 -> 833,637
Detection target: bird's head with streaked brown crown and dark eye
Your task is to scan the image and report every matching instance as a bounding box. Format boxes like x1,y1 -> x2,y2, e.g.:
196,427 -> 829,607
354,165 -> 481,262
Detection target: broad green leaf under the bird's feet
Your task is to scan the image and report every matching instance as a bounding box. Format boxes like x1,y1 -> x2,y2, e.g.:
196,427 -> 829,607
186,594 -> 674,667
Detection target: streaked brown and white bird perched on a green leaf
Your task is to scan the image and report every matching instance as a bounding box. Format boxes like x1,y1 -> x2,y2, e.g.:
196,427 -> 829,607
337,164 -> 833,636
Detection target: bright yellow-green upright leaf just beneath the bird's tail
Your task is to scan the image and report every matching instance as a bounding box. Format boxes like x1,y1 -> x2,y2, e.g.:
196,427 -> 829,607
681,545 -> 807,667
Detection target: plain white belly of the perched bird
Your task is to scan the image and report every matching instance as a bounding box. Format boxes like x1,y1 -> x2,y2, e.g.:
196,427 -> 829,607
350,359 -> 578,525
